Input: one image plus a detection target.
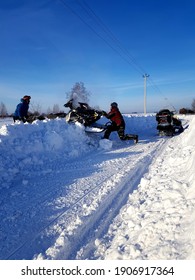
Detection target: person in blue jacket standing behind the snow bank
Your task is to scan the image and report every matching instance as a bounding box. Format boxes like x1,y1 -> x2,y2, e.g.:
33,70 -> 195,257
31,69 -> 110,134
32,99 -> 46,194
13,95 -> 31,123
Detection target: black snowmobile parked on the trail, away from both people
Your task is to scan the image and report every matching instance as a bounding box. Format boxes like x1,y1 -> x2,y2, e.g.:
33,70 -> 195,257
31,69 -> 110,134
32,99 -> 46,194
156,109 -> 183,136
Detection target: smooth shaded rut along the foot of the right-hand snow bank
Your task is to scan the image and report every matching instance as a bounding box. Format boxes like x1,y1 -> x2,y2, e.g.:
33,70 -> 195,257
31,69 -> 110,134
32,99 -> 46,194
70,141 -> 168,259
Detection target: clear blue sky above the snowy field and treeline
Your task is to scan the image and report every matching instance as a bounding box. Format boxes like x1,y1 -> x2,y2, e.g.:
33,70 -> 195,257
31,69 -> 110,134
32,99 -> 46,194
0,0 -> 195,113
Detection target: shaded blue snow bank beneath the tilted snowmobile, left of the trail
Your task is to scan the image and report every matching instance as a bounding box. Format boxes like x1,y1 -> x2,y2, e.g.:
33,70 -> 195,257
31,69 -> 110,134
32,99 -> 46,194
0,119 -> 91,188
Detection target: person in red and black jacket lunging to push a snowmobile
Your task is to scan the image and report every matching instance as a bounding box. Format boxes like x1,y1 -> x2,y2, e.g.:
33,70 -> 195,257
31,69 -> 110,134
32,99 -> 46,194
103,102 -> 138,143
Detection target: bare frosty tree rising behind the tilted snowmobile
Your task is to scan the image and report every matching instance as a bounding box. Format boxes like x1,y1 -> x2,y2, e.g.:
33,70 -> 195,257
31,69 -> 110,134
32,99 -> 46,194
67,82 -> 90,106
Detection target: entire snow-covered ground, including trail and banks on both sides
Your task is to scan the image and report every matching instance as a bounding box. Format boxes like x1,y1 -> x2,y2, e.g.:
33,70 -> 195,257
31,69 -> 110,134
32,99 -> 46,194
0,114 -> 195,260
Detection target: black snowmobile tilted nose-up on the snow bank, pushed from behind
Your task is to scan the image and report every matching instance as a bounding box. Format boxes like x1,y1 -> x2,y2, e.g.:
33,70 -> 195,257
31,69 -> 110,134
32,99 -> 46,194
64,99 -> 106,132
